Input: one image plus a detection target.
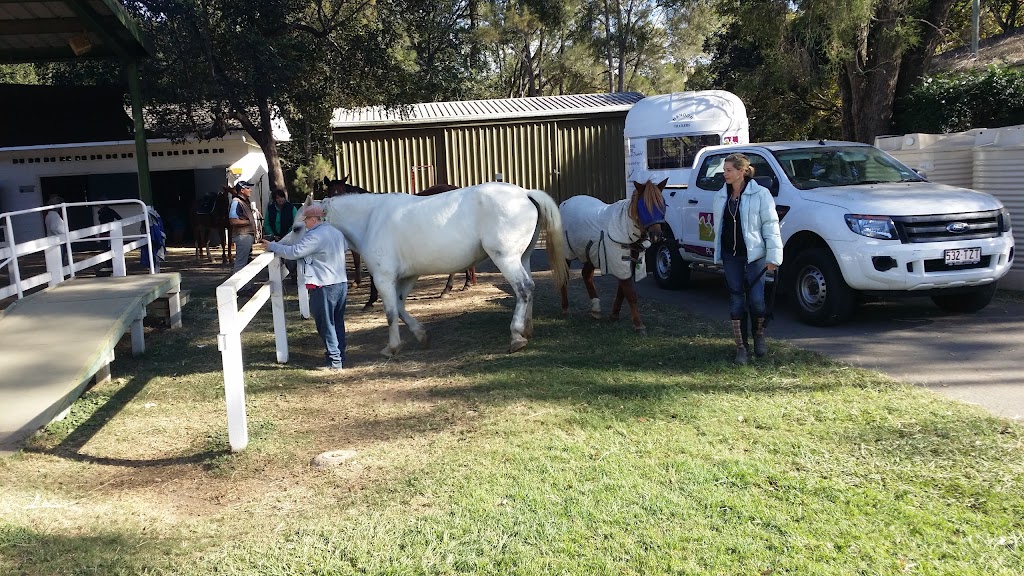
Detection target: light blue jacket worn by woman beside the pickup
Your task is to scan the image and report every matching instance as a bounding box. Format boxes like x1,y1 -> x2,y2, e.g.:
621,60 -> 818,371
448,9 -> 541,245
712,180 -> 782,265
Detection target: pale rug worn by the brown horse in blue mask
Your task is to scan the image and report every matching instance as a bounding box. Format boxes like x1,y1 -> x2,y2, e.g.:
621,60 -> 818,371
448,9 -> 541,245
558,196 -> 646,281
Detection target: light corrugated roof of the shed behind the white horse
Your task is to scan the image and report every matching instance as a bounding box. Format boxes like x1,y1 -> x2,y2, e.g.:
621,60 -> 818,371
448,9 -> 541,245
331,92 -> 644,130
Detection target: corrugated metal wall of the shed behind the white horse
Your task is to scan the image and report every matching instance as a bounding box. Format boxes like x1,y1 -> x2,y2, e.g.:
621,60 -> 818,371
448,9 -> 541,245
335,112 -> 626,203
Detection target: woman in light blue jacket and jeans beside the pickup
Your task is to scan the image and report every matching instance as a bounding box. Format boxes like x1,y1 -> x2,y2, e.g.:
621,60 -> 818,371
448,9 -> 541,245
712,154 -> 782,364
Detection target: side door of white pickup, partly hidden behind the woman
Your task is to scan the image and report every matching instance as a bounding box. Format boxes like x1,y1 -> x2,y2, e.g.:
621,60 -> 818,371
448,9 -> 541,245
683,151 -> 779,261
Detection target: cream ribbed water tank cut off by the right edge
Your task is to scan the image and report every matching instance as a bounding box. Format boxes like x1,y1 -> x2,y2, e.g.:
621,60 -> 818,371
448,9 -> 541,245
974,125 -> 1024,282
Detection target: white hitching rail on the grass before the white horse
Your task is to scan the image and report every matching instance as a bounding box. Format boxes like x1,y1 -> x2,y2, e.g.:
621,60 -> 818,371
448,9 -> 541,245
217,252 -> 309,452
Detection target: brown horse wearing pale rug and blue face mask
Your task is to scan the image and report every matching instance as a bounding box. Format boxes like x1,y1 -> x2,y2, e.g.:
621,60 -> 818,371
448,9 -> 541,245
548,178 -> 669,336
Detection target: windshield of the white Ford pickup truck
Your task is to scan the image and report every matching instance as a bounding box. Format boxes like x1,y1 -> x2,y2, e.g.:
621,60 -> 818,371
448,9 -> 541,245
772,146 -> 924,190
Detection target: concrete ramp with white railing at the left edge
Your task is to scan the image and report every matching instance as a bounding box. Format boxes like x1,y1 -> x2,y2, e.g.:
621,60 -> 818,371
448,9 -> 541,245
0,273 -> 181,452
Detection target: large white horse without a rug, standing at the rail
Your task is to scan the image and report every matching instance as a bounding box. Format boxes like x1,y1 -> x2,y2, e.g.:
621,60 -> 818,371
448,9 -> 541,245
282,182 -> 568,357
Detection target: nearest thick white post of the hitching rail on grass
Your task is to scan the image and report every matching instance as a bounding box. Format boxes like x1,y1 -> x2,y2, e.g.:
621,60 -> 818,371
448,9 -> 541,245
217,285 -> 249,452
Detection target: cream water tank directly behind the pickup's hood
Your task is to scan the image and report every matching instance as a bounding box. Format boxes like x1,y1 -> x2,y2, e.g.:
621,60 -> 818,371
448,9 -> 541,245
876,128 -> 988,188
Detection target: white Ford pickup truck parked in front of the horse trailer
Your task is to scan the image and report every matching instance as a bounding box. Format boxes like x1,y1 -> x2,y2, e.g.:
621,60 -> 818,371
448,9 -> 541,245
647,140 -> 1014,326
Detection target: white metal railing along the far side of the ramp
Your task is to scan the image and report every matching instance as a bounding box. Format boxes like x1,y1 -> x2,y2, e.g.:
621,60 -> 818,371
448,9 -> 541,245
0,200 -> 156,298
